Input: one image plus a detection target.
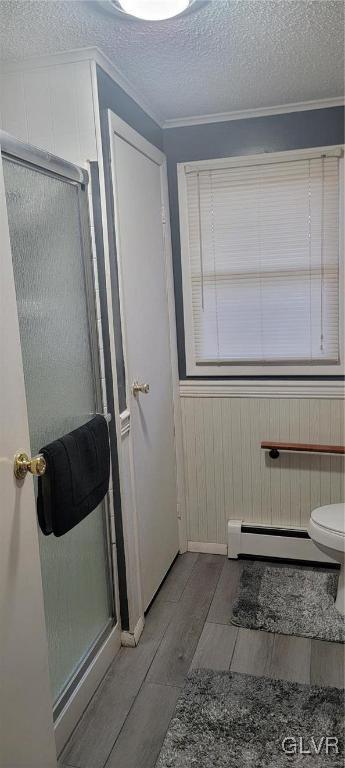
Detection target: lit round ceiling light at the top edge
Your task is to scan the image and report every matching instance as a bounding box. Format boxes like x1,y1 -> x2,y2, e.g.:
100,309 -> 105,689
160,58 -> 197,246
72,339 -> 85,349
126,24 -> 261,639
101,0 -> 196,21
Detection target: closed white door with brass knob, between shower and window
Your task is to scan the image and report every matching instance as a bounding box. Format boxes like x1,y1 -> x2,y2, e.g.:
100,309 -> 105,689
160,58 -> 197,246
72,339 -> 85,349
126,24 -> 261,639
109,113 -> 179,609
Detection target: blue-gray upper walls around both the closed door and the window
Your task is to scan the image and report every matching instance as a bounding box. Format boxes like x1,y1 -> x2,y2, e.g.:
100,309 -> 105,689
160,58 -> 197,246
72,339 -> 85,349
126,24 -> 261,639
97,72 -> 344,380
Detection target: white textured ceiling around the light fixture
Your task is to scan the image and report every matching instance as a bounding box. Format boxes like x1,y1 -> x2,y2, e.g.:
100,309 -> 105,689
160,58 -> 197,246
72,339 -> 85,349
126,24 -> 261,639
0,0 -> 344,119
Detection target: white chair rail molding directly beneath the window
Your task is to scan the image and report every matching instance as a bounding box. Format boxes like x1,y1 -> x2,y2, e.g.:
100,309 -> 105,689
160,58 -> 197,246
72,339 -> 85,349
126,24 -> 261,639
180,379 -> 345,400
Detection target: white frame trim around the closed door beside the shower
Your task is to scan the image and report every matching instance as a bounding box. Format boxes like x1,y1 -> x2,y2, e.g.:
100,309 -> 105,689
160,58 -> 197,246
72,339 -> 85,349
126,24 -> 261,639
107,109 -> 187,620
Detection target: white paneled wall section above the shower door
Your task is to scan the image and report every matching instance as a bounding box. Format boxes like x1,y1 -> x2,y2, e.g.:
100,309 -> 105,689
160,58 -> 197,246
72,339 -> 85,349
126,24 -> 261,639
0,60 -> 97,164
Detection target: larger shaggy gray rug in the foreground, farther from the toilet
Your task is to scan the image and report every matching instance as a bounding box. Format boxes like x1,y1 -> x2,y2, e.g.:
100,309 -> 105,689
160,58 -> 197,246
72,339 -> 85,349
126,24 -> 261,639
156,669 -> 344,768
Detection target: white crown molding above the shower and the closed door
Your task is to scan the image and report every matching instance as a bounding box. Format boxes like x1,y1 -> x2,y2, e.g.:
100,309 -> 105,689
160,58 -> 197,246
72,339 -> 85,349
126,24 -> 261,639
1,46 -> 163,128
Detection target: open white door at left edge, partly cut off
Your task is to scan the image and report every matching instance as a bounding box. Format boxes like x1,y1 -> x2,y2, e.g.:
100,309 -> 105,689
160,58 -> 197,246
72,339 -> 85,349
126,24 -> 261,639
0,155 -> 56,768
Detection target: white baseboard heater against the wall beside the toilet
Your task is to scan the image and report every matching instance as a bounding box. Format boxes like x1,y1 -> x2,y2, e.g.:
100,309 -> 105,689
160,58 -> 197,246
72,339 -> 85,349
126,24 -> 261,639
228,520 -> 336,564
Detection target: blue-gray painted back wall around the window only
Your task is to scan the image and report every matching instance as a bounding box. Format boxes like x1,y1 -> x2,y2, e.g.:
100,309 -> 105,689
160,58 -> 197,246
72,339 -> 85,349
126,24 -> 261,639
163,107 -> 344,379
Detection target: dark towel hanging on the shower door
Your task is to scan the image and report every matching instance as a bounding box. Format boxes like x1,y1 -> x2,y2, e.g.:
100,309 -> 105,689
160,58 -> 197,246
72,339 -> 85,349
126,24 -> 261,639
37,416 -> 110,536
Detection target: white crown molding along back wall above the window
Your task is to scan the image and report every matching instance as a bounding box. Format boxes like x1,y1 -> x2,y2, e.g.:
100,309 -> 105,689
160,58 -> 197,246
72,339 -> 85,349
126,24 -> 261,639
162,96 -> 345,129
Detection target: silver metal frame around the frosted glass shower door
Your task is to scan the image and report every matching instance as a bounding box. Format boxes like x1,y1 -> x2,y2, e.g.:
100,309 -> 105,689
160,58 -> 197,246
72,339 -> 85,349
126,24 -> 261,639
0,130 -> 120,753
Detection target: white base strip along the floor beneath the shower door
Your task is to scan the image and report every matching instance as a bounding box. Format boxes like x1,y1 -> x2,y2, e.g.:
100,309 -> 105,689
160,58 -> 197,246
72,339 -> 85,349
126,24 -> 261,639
54,626 -> 121,756
